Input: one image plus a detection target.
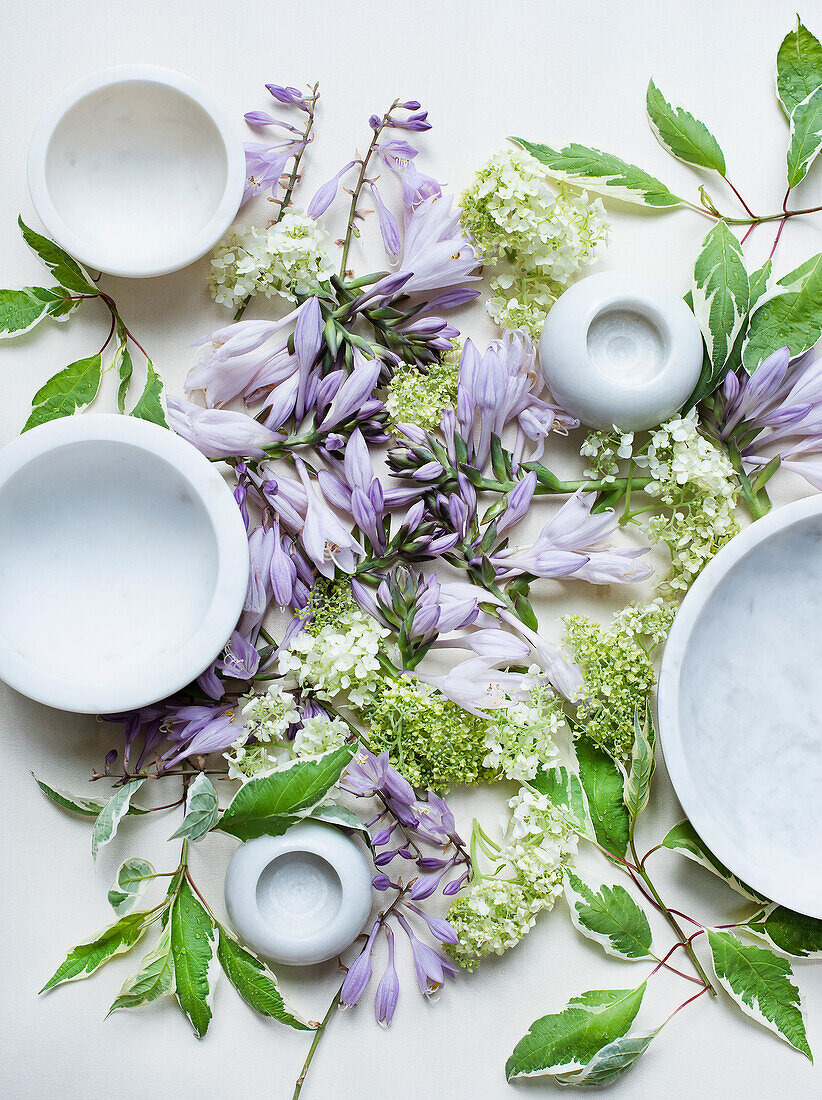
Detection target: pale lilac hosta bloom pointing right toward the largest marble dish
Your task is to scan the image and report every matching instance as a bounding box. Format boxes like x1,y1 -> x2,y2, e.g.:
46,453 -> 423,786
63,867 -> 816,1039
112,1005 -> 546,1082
491,492 -> 651,584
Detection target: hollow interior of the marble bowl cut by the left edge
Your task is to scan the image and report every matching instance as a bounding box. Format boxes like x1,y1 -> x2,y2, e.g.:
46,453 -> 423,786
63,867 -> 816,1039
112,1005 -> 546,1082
0,440 -> 218,697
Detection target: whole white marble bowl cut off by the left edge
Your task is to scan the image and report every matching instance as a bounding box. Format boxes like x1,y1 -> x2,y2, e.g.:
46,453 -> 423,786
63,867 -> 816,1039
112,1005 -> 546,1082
0,414 -> 249,714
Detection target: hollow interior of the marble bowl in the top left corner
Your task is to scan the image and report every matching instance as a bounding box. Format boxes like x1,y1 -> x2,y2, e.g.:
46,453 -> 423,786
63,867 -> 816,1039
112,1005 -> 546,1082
45,79 -> 229,271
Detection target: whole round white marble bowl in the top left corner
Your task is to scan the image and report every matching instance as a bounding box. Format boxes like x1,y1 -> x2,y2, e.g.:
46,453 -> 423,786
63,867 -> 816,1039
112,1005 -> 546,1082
29,65 -> 245,278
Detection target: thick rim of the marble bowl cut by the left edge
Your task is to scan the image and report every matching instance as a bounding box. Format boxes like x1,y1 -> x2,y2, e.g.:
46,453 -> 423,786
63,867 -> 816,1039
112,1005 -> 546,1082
0,413 -> 249,714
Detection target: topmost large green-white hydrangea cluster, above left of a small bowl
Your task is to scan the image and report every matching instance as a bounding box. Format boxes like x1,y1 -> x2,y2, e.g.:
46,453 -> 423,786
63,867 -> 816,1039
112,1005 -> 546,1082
460,146 -> 610,336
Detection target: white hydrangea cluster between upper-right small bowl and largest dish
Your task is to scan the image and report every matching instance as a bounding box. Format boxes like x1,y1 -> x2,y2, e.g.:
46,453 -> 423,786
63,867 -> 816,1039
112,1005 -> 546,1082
634,409 -> 739,596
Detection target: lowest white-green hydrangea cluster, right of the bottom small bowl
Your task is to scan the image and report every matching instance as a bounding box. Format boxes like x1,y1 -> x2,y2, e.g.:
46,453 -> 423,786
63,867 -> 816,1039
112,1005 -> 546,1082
448,787 -> 577,970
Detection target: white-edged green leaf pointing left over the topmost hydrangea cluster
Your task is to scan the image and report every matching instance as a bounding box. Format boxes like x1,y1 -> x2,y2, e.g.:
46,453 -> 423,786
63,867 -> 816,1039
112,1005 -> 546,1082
511,138 -> 683,210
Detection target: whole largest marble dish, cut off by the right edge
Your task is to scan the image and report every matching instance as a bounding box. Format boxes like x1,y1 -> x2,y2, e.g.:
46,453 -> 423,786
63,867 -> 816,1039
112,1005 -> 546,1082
659,496 -> 822,917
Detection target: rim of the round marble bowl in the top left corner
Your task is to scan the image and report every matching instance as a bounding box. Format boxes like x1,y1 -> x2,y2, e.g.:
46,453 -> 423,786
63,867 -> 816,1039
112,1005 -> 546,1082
26,64 -> 245,278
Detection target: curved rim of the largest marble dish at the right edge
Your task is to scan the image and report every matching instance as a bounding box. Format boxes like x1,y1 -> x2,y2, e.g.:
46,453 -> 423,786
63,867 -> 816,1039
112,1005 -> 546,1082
657,495 -> 822,919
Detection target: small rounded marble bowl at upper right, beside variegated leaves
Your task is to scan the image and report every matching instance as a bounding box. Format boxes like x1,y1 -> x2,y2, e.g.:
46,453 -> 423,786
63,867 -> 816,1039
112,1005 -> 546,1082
539,271 -> 702,431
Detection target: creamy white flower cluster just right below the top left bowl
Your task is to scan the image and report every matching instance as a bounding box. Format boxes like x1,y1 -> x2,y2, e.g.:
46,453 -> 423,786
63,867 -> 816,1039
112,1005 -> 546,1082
209,208 -> 335,308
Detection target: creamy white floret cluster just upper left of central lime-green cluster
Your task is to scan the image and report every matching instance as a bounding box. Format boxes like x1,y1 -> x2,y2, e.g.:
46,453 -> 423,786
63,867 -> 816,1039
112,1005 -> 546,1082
278,611 -> 391,706
